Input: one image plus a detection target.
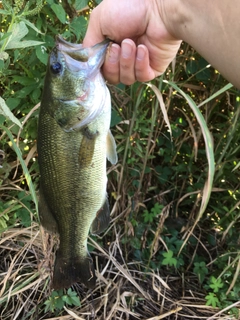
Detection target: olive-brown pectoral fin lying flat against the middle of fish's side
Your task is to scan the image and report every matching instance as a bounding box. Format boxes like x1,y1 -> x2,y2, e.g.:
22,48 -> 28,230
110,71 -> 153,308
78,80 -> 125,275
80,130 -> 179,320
78,127 -> 98,167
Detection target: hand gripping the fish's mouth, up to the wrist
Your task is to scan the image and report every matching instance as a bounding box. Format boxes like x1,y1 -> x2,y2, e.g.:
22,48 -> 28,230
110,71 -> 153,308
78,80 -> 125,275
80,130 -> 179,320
83,0 -> 181,85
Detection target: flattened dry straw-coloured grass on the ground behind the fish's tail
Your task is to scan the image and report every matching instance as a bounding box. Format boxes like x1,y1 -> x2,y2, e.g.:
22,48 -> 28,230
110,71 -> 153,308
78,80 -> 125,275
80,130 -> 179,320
0,223 -> 237,320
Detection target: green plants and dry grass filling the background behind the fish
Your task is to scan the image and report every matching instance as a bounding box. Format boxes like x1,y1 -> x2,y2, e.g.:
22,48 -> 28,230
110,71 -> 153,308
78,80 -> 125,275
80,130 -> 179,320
0,0 -> 240,320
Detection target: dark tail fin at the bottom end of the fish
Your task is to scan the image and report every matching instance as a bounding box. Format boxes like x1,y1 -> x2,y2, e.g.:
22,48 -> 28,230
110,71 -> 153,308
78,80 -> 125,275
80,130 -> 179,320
52,251 -> 96,290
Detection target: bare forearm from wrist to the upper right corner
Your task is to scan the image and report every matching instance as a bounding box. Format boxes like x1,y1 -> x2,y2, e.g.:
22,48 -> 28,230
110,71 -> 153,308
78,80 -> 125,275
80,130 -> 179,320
159,0 -> 240,88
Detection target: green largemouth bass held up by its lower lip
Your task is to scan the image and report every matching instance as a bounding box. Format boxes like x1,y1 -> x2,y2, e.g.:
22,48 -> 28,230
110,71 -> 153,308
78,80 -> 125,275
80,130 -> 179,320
37,36 -> 117,290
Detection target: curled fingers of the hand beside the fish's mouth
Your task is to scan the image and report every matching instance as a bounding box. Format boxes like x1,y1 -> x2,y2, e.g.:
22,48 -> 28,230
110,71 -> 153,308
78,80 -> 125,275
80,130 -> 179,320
102,39 -> 156,85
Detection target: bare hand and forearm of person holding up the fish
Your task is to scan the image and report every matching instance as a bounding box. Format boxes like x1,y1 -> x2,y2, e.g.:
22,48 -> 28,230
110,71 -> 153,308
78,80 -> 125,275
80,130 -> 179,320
83,0 -> 240,88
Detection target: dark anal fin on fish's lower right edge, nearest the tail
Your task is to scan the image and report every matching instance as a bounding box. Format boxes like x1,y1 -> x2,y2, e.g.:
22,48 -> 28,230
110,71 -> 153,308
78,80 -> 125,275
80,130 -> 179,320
91,198 -> 110,234
